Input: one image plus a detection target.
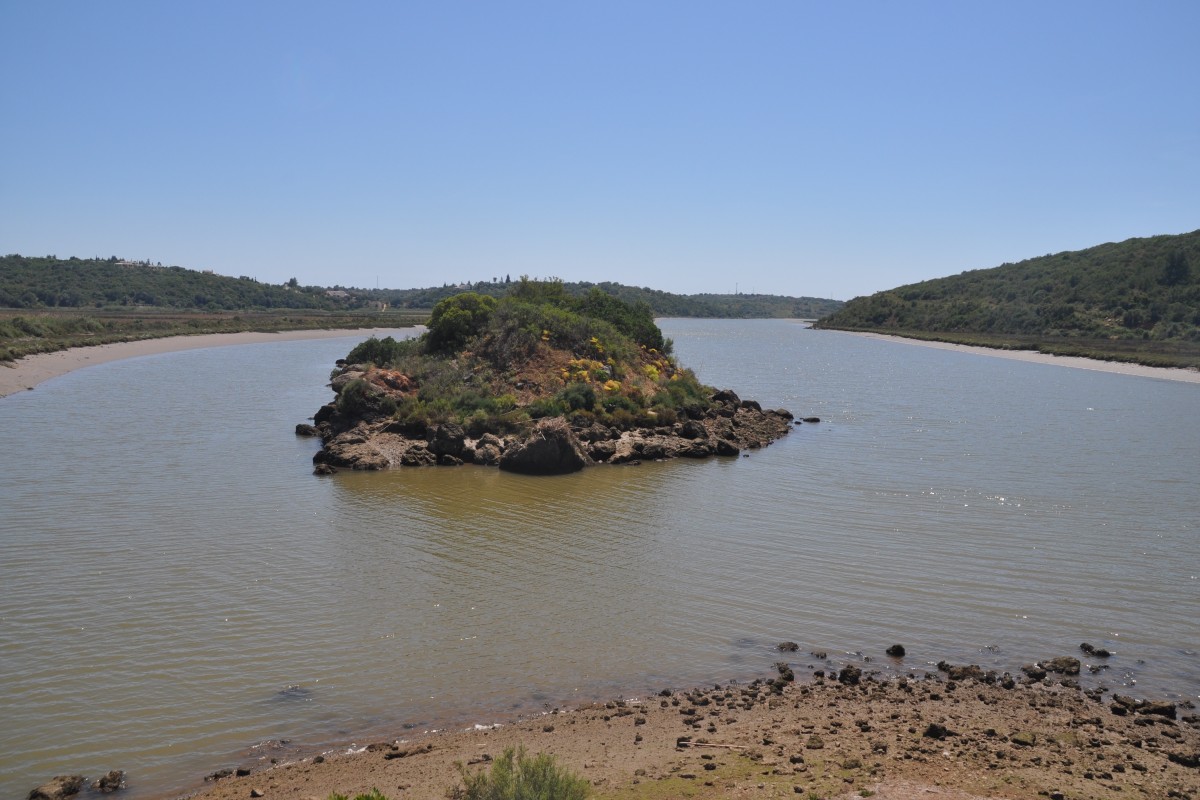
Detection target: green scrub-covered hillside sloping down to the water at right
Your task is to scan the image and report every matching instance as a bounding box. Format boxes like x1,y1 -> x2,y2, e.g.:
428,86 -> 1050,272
816,230 -> 1200,367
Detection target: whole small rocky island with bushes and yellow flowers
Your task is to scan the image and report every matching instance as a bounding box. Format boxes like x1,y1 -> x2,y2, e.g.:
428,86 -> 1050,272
296,277 -> 793,475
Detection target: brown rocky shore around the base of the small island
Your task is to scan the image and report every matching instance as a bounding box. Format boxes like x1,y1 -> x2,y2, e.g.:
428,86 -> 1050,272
296,365 -> 796,475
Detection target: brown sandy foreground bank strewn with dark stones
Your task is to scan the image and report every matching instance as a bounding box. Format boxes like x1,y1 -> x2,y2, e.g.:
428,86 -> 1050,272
171,654 -> 1200,800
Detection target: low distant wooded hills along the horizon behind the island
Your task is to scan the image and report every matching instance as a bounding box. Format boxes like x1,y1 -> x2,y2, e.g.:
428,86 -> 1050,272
0,255 -> 842,319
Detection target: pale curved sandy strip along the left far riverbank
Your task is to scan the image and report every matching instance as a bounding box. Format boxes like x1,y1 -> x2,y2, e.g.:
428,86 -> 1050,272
0,327 -> 412,397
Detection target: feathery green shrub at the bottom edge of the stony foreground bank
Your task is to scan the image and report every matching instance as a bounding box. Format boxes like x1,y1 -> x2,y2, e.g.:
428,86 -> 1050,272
448,747 -> 590,800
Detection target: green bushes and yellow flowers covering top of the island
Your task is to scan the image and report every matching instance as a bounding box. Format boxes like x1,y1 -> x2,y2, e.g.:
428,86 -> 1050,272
337,278 -> 713,437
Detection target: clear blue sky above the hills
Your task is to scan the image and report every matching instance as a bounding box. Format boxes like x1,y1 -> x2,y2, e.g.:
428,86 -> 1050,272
0,0 -> 1200,299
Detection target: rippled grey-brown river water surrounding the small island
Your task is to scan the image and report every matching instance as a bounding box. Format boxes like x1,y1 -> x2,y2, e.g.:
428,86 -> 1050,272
0,320 -> 1200,799
